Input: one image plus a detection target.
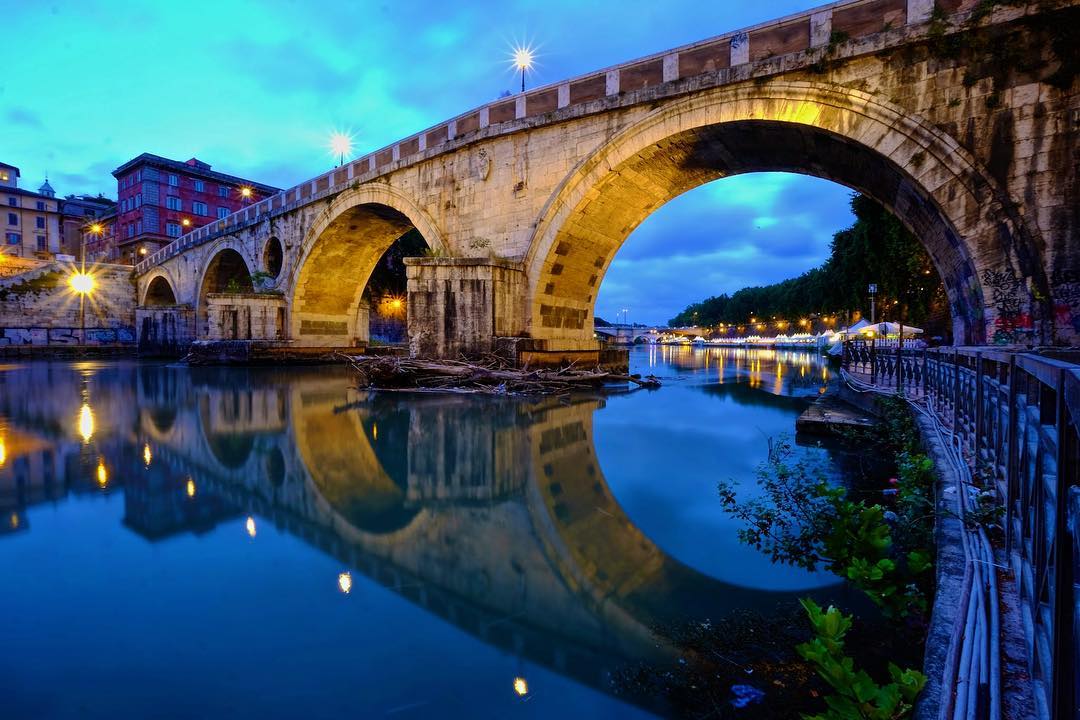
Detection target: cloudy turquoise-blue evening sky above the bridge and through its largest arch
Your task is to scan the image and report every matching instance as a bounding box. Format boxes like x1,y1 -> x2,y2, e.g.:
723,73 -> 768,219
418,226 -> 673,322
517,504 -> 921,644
0,0 -> 851,323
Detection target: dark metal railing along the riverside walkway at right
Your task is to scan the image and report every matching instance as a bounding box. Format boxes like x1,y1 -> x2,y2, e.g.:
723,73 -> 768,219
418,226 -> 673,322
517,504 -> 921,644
843,341 -> 1080,720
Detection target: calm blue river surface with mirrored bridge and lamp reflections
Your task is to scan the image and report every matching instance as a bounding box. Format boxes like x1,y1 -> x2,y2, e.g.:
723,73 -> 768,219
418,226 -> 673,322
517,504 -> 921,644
0,348 -> 836,718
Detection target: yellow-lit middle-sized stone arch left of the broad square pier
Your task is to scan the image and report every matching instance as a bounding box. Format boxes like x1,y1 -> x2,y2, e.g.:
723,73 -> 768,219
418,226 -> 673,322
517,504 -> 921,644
289,182 -> 445,347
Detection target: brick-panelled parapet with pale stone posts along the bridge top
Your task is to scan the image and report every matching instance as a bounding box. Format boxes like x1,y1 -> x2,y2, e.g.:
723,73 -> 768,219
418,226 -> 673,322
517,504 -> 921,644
136,0 -> 993,274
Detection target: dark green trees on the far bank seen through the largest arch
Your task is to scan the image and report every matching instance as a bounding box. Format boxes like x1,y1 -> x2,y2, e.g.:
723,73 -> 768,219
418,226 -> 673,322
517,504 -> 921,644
669,194 -> 945,327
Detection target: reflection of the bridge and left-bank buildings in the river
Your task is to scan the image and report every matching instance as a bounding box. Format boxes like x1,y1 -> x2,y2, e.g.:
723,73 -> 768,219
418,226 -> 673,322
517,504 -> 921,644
0,351 -> 842,716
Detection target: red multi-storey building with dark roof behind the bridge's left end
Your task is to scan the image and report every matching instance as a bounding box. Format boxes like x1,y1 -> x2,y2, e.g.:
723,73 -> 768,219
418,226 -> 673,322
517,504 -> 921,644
108,152 -> 280,263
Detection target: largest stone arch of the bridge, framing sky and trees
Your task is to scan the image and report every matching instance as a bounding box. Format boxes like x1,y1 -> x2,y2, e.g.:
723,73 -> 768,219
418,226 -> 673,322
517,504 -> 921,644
525,81 -> 1049,350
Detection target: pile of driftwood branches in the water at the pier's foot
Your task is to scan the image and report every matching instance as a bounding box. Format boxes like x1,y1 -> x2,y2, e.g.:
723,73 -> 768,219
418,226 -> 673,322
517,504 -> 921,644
348,355 -> 660,395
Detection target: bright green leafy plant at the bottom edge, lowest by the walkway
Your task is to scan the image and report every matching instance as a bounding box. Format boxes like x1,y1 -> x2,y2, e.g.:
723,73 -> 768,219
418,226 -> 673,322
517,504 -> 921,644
795,598 -> 927,720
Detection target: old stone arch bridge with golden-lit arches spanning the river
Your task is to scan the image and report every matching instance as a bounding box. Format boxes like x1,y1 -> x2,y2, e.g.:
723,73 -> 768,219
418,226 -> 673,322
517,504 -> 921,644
137,0 -> 1080,361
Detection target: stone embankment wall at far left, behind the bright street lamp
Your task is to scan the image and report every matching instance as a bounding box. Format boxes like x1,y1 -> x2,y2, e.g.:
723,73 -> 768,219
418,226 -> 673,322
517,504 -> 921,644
0,262 -> 136,355
